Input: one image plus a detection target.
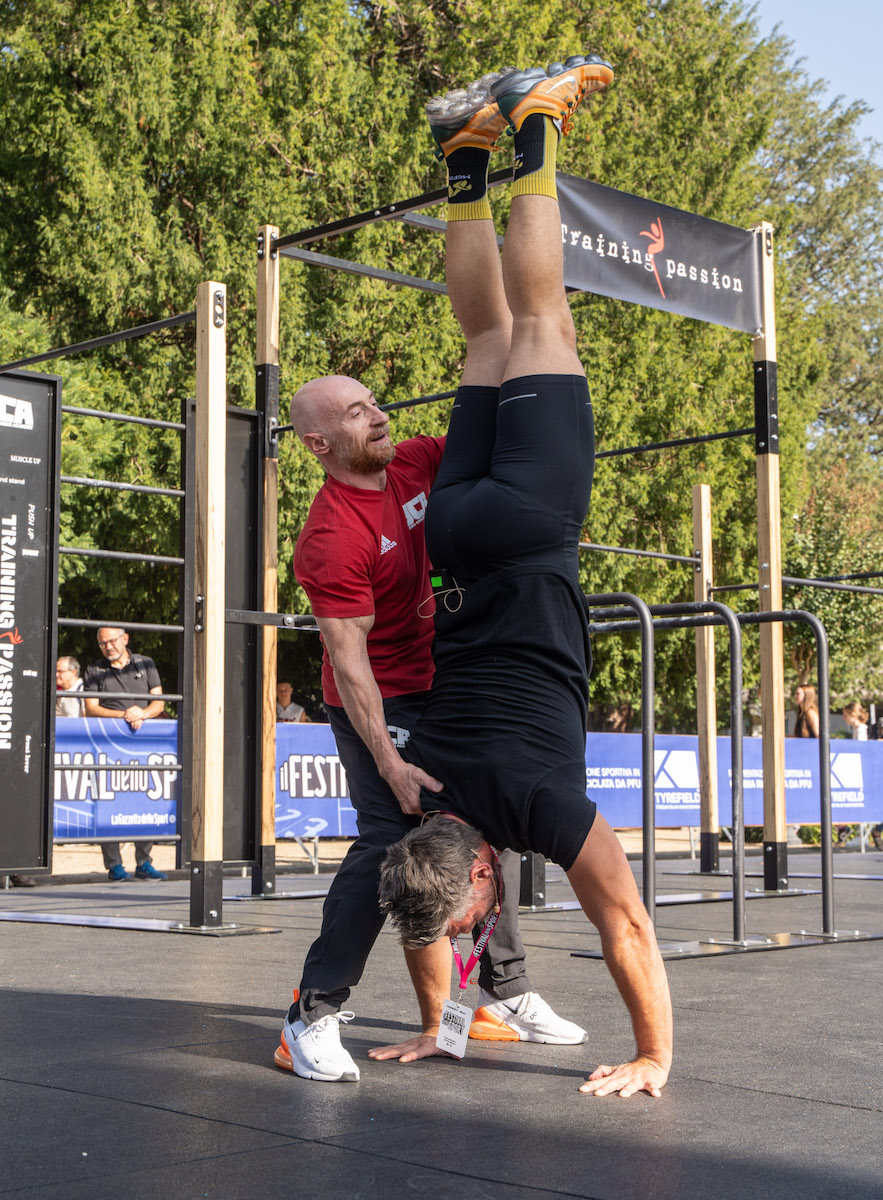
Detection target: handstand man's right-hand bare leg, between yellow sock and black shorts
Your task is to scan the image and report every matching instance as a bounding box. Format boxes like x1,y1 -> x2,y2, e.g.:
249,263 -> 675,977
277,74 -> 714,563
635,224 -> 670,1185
503,196 -> 585,380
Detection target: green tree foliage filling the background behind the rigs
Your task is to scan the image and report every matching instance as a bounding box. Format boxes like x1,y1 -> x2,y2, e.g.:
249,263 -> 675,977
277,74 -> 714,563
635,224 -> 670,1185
0,0 -> 883,710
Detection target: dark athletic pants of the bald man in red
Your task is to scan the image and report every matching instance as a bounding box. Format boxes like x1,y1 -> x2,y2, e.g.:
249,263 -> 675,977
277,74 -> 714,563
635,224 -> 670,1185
290,692 -> 533,1024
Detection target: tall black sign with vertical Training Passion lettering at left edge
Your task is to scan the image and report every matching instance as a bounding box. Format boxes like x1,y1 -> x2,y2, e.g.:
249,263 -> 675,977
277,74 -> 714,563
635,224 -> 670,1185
0,373 -> 61,872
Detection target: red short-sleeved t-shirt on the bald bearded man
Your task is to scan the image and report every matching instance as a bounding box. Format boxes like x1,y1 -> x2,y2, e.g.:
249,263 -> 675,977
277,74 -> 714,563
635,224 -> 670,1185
294,434 -> 444,707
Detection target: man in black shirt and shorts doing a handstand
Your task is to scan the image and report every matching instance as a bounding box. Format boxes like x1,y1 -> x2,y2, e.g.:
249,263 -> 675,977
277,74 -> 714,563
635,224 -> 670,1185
380,56 -> 672,1096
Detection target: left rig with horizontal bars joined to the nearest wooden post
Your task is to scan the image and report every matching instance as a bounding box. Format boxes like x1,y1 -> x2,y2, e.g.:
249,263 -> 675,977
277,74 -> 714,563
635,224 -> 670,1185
0,282 -> 279,936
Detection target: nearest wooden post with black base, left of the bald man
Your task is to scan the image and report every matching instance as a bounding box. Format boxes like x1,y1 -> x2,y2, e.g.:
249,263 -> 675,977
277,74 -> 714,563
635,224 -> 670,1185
190,282 -> 227,928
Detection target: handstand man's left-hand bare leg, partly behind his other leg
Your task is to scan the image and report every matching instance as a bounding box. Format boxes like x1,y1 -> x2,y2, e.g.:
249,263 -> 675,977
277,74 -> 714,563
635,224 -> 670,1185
446,221 -> 512,388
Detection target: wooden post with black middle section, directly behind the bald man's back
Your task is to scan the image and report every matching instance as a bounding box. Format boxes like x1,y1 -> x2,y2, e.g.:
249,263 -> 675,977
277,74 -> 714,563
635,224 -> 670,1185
252,226 -> 280,895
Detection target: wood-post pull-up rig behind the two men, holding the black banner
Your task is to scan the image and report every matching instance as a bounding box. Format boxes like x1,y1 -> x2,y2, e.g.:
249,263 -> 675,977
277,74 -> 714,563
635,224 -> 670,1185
249,170 -> 788,894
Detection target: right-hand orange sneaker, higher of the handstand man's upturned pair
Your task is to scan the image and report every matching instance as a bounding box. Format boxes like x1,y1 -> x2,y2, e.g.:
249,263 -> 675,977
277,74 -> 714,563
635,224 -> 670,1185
491,54 -> 613,136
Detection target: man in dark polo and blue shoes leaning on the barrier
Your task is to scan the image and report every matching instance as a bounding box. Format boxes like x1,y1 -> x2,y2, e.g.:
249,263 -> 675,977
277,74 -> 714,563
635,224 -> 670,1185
83,626 -> 168,883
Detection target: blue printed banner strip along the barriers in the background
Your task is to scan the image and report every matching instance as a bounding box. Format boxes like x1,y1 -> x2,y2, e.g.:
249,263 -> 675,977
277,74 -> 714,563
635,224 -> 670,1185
55,718 -> 883,841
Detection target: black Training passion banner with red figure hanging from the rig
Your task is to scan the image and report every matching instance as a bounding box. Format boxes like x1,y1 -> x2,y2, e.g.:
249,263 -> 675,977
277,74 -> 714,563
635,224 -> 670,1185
558,173 -> 763,334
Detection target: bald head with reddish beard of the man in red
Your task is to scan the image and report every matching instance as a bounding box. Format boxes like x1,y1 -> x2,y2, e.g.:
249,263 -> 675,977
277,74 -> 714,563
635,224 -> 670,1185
290,376 -> 396,487
